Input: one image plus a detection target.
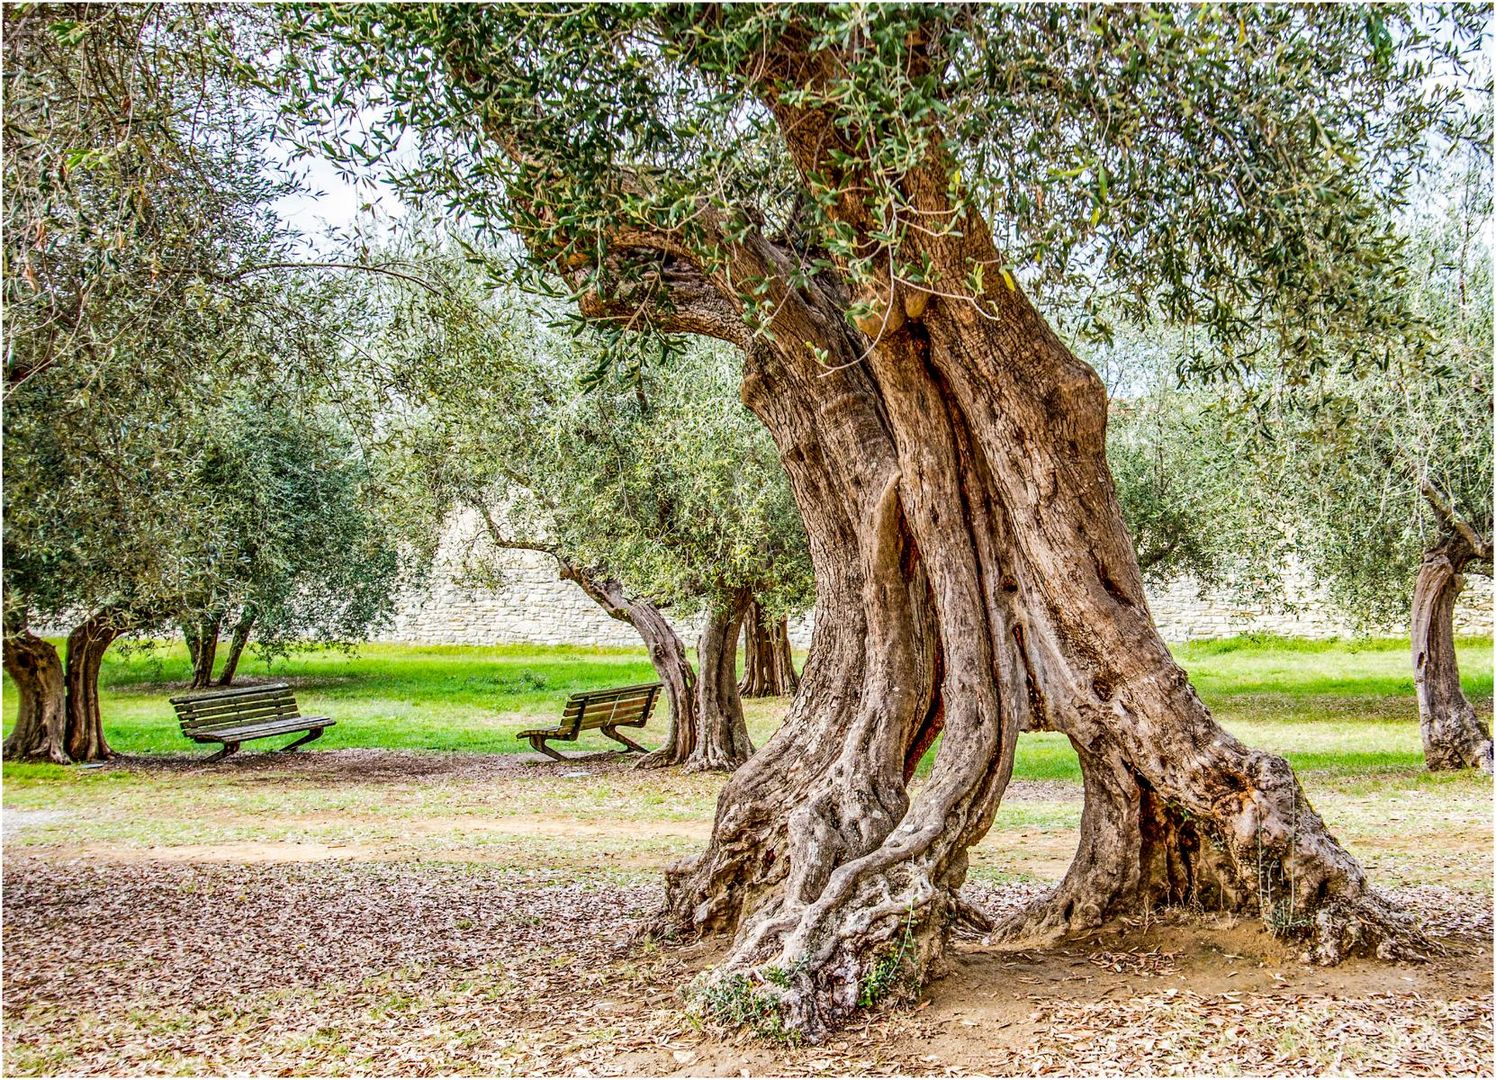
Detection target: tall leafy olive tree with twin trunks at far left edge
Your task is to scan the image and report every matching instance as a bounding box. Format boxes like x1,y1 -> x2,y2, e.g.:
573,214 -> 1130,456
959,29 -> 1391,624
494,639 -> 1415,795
3,4 -> 297,760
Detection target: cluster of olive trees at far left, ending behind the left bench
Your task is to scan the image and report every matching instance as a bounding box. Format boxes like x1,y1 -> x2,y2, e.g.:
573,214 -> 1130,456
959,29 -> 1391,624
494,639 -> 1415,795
4,6 -> 398,761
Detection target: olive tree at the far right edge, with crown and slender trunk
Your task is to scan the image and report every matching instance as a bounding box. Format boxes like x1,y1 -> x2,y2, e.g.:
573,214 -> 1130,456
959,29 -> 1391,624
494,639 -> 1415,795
1281,155 -> 1493,772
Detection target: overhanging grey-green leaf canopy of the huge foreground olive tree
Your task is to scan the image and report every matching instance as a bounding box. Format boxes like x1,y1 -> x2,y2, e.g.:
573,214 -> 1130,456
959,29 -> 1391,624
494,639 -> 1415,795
278,3 -> 1486,377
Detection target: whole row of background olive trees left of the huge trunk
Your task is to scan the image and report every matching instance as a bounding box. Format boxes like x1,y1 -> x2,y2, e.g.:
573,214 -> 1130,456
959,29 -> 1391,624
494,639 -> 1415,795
4,6 -> 811,767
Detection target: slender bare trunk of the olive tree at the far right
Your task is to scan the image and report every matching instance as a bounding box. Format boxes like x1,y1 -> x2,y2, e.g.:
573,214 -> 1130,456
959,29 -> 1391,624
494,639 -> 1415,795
1411,537 -> 1492,772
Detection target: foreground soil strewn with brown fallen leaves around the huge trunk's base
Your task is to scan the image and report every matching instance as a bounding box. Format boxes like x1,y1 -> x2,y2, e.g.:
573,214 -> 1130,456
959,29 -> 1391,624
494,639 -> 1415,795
3,856 -> 1492,1076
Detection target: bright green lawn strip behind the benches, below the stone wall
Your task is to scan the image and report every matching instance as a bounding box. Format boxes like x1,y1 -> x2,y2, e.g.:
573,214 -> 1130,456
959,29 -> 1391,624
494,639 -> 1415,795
4,637 -> 1492,781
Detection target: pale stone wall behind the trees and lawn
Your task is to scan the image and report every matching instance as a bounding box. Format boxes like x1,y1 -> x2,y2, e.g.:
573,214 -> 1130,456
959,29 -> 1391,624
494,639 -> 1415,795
380,505 -> 1492,649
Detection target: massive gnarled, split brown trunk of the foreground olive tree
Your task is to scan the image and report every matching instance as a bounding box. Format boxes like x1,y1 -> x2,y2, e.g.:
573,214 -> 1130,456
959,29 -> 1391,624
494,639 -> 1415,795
466,15 -> 1423,1040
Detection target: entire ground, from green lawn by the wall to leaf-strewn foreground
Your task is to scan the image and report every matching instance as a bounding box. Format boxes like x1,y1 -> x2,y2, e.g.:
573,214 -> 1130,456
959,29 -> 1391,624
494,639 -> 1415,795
3,639 -> 1492,1076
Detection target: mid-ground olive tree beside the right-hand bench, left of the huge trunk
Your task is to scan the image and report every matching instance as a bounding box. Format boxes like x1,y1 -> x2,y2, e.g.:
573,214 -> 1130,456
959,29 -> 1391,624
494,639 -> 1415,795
365,238 -> 811,769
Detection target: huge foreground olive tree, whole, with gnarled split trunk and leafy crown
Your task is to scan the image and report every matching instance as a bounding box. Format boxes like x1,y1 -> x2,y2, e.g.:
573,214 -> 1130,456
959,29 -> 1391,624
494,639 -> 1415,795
287,4 -> 1480,1038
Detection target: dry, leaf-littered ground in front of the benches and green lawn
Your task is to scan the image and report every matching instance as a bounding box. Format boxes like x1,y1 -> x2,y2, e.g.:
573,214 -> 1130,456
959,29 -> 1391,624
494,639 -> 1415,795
3,751 -> 1492,1076
